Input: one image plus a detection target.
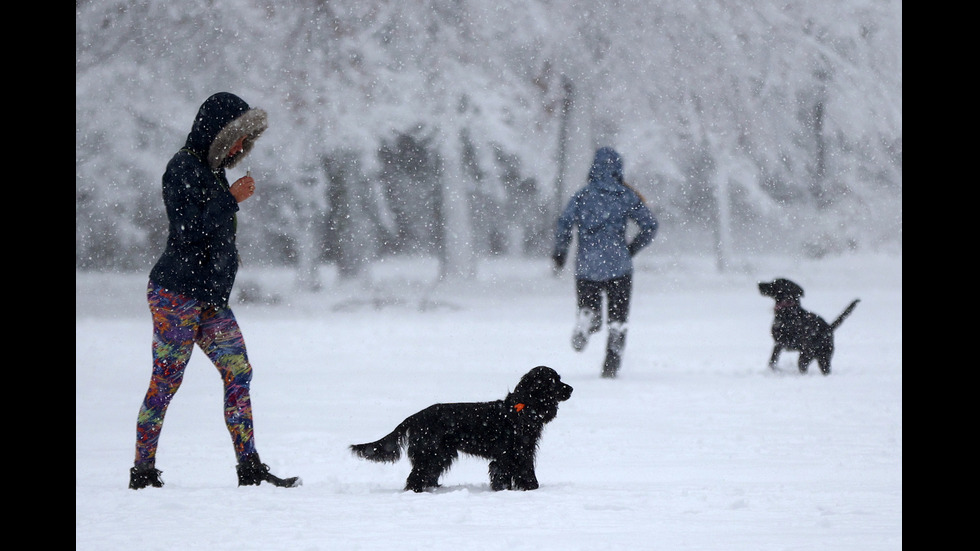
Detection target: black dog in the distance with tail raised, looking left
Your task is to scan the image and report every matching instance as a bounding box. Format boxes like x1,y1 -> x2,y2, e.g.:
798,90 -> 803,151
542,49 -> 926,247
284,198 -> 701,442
759,278 -> 860,375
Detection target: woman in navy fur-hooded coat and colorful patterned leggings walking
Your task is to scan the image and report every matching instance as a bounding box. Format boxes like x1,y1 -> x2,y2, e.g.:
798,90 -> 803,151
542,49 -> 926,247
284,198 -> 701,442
129,92 -> 299,490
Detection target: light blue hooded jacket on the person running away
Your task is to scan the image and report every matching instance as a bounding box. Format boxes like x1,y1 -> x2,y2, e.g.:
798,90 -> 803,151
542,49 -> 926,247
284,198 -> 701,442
554,147 -> 657,281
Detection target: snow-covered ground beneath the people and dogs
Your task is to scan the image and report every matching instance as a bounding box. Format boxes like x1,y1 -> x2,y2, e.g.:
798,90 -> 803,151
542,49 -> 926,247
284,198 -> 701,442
75,252 -> 902,551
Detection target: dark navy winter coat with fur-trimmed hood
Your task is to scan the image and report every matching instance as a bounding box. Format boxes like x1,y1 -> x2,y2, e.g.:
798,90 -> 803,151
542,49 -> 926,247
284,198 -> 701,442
150,92 -> 268,306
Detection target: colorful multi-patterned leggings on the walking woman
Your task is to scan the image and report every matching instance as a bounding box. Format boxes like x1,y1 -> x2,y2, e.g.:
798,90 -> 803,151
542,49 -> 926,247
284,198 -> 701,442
135,281 -> 255,464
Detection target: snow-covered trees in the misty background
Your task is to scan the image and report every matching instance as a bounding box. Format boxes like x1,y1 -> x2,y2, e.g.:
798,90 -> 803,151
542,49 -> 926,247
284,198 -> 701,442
75,0 -> 902,287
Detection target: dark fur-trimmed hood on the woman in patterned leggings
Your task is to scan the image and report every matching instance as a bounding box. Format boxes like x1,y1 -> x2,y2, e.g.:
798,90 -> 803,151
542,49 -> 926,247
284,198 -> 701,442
185,92 -> 269,170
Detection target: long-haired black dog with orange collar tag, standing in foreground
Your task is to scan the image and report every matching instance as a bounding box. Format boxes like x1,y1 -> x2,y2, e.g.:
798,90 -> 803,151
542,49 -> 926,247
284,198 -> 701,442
350,365 -> 572,492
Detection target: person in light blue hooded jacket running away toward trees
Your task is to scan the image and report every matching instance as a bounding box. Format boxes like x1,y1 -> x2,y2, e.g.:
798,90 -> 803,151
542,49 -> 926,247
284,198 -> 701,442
552,147 -> 657,378
